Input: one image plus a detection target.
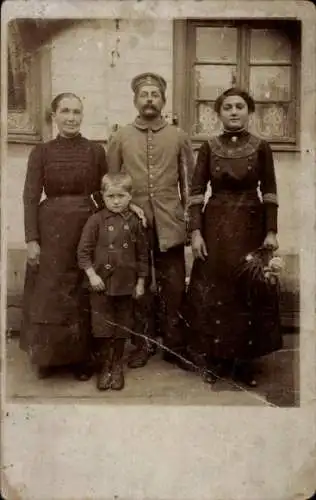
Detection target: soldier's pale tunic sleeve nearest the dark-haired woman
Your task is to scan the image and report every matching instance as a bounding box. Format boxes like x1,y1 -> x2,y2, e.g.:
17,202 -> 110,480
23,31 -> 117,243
178,130 -> 195,211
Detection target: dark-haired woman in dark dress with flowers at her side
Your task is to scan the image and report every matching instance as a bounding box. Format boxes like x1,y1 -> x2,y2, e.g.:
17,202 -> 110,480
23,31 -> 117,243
185,88 -> 282,386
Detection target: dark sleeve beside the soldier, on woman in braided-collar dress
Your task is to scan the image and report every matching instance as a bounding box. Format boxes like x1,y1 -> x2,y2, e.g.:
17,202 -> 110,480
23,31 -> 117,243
189,142 -> 210,232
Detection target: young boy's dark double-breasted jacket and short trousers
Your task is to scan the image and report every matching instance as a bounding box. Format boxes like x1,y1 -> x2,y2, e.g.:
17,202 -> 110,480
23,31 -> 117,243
78,208 -> 148,338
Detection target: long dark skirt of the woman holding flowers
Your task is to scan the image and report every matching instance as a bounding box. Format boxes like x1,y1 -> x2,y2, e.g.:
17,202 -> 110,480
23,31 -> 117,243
184,193 -> 282,360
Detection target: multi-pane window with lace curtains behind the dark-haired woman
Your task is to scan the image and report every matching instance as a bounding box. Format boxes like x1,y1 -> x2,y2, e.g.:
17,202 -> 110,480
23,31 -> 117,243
174,20 -> 300,147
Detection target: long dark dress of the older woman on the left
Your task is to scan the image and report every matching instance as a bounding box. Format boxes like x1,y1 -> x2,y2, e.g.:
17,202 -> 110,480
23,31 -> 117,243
21,134 -> 107,366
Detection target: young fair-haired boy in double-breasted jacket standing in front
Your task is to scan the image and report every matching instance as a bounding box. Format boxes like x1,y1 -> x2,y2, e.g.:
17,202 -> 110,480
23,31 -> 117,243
78,172 -> 148,391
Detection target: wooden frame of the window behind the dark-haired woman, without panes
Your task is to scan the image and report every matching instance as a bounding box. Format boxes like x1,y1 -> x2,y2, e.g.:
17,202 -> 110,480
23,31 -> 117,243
173,19 -> 301,151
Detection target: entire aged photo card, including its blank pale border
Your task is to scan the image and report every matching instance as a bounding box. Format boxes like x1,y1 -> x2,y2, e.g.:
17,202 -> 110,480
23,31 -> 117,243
1,0 -> 316,500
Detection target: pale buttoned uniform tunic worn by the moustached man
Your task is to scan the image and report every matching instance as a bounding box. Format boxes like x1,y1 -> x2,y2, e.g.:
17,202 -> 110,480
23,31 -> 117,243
107,117 -> 194,251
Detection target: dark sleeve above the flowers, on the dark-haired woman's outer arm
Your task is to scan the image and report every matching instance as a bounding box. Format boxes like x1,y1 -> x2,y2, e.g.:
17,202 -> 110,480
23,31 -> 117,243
258,141 -> 278,233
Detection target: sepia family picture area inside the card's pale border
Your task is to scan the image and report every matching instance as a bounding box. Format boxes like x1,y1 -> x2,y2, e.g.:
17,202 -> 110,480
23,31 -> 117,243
7,13 -> 301,406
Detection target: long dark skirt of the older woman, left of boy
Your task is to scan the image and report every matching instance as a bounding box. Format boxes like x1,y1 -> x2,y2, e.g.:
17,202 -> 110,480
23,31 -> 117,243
20,196 -> 92,367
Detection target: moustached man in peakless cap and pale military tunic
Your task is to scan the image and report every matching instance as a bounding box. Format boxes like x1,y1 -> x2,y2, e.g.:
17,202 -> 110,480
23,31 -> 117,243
107,73 -> 194,368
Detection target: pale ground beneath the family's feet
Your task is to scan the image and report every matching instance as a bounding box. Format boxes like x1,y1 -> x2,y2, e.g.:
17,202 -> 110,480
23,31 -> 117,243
5,334 -> 299,407
